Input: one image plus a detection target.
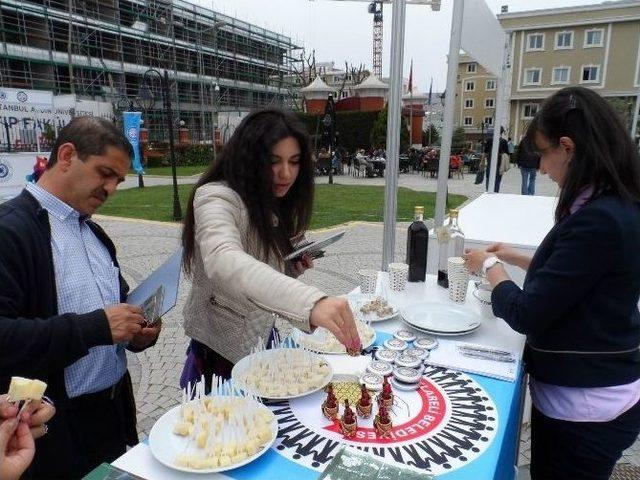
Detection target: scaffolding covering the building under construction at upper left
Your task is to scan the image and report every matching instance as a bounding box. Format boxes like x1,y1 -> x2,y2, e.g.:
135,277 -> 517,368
0,0 -> 300,142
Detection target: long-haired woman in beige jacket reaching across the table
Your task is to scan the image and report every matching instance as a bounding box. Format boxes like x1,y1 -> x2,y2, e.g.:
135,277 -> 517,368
181,109 -> 361,389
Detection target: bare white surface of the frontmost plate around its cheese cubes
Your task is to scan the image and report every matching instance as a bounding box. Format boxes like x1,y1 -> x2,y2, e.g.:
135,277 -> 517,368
149,402 -> 278,473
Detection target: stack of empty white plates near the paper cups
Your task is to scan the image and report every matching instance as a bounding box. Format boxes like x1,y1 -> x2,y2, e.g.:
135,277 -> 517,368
401,302 -> 480,336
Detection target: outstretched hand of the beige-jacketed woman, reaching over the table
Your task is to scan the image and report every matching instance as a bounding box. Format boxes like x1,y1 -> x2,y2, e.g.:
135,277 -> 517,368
309,297 -> 362,351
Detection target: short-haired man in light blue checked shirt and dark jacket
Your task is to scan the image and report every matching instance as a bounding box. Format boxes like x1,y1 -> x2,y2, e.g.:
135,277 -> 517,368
0,117 -> 160,480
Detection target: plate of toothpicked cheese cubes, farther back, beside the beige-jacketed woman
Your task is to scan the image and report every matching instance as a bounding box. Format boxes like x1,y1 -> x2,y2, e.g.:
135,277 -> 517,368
231,348 -> 333,400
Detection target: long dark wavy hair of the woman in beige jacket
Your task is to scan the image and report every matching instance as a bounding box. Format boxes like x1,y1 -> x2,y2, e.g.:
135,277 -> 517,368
182,108 -> 314,273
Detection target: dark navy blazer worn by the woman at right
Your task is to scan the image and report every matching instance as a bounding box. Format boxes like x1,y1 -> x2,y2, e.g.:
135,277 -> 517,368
492,195 -> 640,387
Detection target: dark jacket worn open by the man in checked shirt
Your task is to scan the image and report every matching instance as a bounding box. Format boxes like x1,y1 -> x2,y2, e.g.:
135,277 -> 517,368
0,190 -> 122,402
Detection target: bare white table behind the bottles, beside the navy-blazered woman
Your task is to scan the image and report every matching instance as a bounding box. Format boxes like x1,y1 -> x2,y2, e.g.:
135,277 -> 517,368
427,193 -> 558,286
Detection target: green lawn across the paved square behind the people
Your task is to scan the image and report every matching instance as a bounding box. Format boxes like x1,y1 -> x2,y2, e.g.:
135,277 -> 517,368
98,185 -> 466,229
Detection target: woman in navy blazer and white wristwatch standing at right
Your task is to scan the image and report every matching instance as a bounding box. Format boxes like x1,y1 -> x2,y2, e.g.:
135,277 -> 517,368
465,87 -> 640,480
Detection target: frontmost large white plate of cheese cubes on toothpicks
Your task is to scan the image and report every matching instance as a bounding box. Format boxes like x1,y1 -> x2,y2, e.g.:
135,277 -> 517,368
149,396 -> 278,473
